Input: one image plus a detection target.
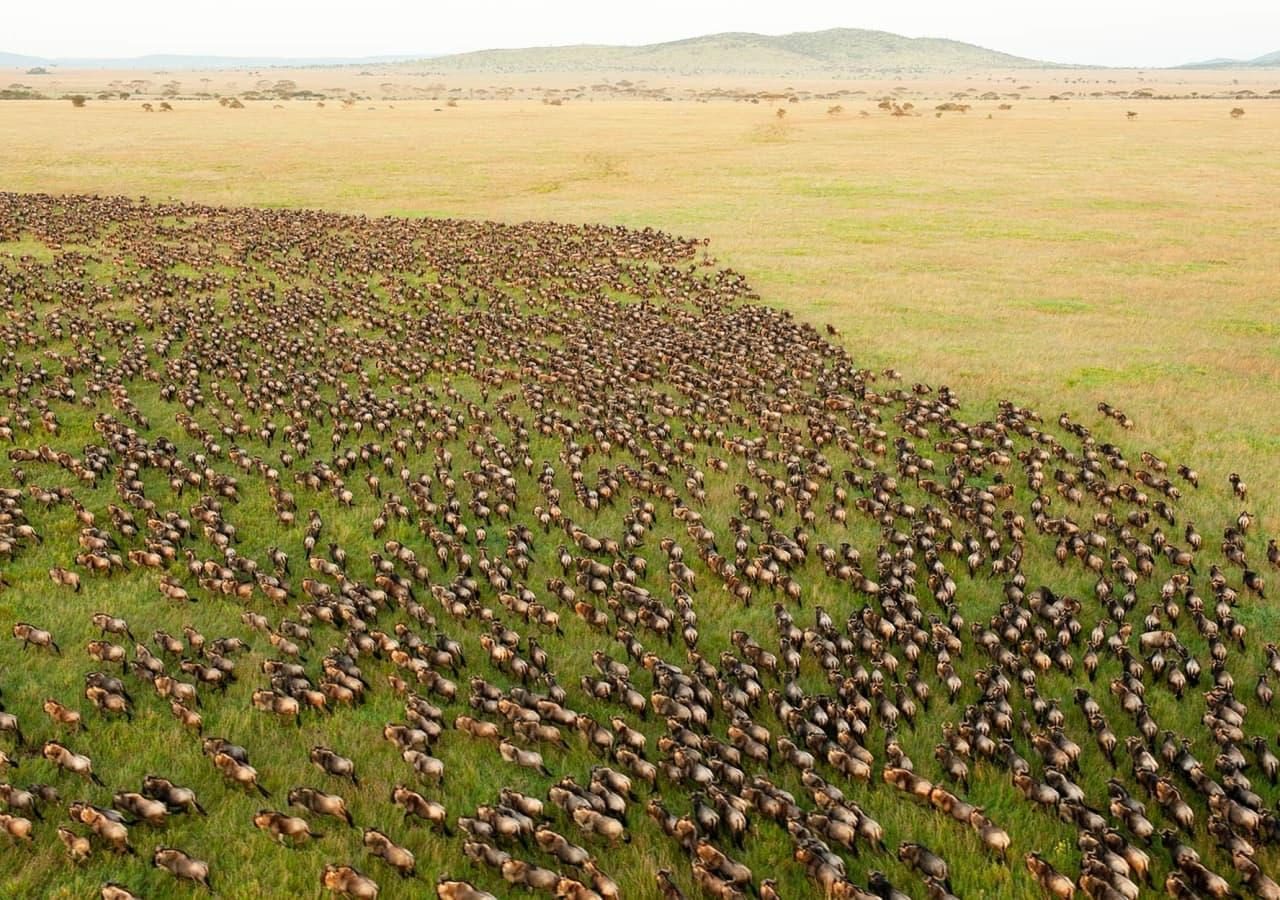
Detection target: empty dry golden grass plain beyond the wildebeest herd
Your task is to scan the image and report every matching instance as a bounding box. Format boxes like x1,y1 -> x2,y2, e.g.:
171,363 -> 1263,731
0,83 -> 1280,531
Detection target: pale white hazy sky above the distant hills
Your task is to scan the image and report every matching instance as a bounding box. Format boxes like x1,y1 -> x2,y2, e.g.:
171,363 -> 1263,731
10,0 -> 1280,67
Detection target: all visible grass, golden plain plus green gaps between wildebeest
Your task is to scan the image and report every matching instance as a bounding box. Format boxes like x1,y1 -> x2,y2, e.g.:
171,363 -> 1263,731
0,87 -> 1280,897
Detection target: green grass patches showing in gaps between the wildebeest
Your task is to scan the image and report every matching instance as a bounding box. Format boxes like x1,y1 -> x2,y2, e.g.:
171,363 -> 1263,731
0,189 -> 1277,897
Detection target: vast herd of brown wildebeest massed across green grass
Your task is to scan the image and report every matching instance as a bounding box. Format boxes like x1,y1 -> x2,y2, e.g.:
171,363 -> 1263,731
0,195 -> 1280,900
